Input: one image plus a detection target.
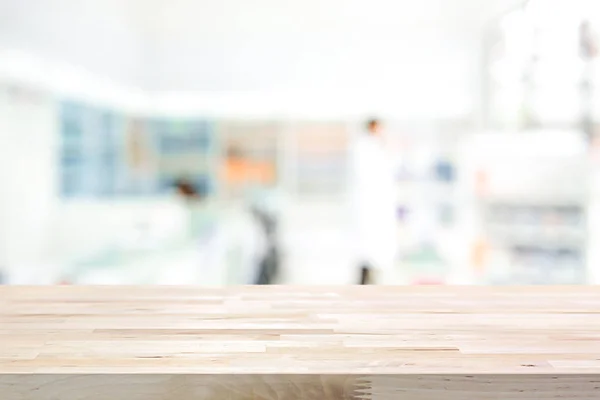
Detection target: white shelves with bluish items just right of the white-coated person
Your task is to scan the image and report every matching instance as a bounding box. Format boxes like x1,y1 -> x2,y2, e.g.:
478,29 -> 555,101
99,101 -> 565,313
389,121 -> 470,284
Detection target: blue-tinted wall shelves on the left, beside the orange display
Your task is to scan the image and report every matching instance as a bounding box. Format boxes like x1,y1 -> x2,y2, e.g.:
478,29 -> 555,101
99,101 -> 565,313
59,101 -> 216,198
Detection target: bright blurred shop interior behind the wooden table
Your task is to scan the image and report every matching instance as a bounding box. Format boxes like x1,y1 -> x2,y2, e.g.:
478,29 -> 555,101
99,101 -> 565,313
0,0 -> 600,286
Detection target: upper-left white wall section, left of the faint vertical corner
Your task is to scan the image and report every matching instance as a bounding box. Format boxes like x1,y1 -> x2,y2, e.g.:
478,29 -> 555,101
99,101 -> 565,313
0,0 -> 147,86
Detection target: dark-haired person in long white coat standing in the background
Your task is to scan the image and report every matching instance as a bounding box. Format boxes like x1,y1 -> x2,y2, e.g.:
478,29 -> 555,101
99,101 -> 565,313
351,119 -> 397,285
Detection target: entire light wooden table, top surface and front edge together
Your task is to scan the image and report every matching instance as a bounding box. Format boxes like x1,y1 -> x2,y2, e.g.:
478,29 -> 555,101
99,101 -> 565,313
0,286 -> 600,400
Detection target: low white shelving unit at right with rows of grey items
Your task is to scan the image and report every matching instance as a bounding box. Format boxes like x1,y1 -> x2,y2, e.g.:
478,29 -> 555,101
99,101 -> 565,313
461,132 -> 592,284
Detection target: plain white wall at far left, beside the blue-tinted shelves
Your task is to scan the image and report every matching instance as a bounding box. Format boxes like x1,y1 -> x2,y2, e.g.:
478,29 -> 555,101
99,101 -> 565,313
0,86 -> 58,282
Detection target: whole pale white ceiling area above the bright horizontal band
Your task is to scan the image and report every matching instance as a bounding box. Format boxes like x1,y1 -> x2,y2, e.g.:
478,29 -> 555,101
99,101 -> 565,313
0,0 -> 522,91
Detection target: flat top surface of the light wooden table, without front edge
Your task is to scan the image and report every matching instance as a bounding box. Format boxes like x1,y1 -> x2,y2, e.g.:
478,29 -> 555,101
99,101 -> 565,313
0,286 -> 600,374
